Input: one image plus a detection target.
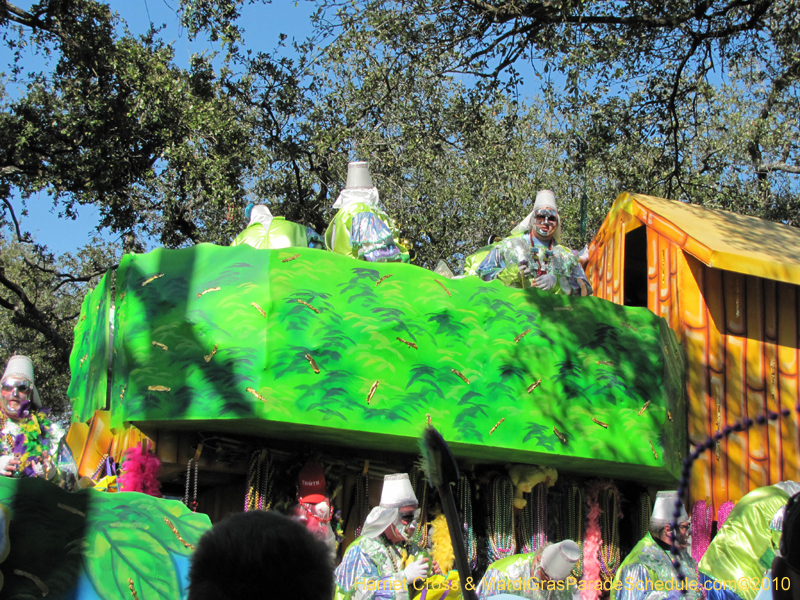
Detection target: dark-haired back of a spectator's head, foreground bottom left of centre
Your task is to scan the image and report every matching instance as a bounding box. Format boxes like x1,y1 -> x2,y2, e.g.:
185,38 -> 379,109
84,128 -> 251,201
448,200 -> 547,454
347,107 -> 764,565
187,511 -> 334,600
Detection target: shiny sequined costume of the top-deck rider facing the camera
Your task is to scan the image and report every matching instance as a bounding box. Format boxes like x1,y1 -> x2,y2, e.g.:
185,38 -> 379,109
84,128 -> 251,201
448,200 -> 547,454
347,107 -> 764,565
465,233 -> 592,296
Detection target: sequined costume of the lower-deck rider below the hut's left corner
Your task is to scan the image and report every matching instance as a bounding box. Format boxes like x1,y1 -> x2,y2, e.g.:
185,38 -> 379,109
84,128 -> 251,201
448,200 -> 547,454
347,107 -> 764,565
610,533 -> 701,600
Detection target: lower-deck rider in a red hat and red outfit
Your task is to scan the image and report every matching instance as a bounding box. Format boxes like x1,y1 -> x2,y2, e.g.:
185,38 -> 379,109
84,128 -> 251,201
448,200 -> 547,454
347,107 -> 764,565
292,458 -> 337,558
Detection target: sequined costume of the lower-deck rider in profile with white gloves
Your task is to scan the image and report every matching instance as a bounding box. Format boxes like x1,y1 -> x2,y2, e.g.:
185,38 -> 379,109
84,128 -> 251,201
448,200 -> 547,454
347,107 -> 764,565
334,536 -> 409,600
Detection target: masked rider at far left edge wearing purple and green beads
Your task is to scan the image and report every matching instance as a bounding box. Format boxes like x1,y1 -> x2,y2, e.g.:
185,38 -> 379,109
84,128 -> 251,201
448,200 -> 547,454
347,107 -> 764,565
0,356 -> 58,479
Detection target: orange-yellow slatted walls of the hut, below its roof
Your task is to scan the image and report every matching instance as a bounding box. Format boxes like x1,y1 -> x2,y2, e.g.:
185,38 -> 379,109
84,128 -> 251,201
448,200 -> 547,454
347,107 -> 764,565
587,202 -> 800,510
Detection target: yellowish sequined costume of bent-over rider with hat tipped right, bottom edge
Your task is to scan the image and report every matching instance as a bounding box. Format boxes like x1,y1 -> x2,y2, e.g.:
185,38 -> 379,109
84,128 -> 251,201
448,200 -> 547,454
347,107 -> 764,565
477,550 -> 577,600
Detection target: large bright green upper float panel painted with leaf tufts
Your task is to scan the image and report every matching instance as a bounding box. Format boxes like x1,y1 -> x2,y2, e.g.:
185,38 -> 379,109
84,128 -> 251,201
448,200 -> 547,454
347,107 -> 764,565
67,244 -> 686,485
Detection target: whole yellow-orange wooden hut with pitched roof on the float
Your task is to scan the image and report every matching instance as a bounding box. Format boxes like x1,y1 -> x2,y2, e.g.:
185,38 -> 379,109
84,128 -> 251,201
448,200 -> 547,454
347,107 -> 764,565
586,193 -> 800,511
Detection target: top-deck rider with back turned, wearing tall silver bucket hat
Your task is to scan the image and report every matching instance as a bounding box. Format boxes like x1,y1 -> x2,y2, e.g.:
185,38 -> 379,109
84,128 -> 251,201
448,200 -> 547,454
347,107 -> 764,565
325,162 -> 409,262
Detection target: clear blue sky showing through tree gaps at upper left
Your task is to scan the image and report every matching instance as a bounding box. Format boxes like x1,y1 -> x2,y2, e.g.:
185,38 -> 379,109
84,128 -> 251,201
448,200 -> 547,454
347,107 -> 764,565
0,0 -> 315,254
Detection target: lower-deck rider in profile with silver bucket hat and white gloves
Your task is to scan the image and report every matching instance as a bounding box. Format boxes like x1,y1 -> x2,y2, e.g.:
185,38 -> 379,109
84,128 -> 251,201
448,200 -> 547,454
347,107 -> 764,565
335,473 -> 429,600
